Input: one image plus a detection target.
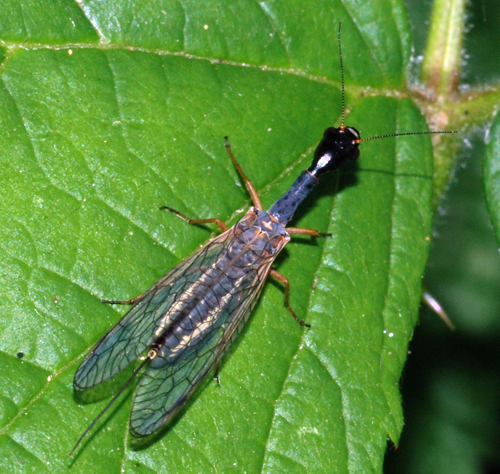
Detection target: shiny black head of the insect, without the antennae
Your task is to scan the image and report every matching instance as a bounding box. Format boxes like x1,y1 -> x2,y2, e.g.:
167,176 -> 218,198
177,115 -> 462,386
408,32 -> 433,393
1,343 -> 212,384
307,126 -> 361,177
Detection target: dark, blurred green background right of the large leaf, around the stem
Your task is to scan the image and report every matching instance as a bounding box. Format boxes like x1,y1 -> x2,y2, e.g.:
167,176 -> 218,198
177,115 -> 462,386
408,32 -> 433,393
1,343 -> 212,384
384,0 -> 500,474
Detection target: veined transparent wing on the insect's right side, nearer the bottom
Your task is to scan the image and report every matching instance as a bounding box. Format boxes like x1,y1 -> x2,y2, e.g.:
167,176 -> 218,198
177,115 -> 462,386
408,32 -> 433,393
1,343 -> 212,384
130,262 -> 272,437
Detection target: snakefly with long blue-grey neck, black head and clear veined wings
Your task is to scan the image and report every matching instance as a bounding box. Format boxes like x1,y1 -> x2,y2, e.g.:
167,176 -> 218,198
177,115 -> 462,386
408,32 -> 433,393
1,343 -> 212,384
70,25 -> 458,454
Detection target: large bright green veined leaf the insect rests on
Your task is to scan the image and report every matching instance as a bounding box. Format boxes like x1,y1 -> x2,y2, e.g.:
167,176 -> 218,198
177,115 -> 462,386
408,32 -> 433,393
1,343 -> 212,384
0,0 -> 432,473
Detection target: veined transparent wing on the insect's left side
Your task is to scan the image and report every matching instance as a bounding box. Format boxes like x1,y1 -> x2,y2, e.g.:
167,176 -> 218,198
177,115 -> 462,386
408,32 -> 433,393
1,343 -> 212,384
73,228 -> 233,390
